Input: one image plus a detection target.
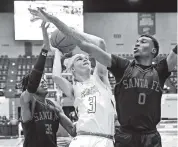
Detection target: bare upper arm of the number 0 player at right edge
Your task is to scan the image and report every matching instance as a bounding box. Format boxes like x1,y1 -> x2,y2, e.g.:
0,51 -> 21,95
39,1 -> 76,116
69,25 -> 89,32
166,45 -> 177,72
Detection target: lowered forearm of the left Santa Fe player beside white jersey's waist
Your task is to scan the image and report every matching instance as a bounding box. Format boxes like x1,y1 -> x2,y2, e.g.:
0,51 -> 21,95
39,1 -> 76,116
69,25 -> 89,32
59,112 -> 77,137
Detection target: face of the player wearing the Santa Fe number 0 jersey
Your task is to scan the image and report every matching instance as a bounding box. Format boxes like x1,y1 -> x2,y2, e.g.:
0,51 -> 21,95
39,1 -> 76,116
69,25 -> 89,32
133,36 -> 154,58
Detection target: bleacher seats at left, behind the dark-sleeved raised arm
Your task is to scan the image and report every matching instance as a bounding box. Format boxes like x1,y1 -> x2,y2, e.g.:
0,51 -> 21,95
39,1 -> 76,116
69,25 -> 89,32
0,55 -> 56,98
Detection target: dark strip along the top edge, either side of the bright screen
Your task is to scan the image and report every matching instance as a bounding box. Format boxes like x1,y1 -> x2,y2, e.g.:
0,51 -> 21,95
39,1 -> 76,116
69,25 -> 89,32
0,0 -> 177,13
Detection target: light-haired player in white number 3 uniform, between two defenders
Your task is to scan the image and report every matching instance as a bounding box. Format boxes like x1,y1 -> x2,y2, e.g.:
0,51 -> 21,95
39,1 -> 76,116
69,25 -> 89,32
50,34 -> 114,147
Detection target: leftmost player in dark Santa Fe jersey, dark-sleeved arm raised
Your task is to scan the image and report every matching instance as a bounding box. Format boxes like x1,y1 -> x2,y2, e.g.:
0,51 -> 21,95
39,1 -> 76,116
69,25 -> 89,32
20,22 -> 76,147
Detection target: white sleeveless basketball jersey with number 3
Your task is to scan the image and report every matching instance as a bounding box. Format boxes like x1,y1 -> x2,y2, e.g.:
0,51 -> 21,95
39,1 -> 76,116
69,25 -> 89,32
73,75 -> 114,135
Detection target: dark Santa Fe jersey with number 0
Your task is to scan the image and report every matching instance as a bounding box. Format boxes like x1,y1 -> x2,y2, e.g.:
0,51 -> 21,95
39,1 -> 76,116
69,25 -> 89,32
108,55 -> 170,130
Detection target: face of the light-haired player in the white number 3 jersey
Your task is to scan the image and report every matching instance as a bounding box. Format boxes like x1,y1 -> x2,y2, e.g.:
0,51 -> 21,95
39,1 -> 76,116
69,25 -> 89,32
73,55 -> 91,73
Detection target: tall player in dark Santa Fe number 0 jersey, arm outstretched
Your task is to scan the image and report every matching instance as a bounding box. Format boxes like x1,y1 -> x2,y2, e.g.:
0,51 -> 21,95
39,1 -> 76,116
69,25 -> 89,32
27,9 -> 177,147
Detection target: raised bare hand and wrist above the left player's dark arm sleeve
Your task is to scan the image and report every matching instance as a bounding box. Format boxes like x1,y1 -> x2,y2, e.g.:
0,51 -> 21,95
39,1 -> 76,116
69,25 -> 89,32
41,21 -> 50,51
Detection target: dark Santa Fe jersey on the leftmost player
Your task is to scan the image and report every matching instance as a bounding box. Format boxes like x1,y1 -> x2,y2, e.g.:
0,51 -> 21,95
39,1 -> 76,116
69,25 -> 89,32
22,101 -> 59,147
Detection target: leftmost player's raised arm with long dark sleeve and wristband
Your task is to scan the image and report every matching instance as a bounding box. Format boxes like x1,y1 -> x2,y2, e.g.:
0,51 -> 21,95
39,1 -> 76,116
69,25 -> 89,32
20,22 -> 49,123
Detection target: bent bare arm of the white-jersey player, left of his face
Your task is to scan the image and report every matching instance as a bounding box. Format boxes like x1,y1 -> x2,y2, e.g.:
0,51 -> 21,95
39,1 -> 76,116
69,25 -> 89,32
52,49 -> 74,98
